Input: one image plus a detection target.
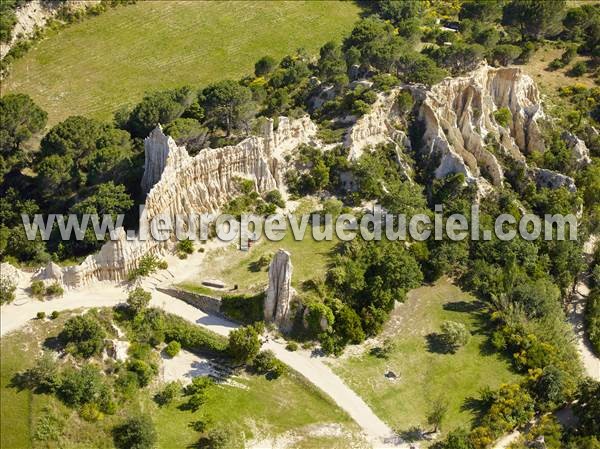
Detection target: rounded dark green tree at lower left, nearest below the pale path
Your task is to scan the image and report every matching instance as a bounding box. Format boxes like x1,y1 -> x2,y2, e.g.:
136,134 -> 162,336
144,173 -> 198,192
59,312 -> 106,358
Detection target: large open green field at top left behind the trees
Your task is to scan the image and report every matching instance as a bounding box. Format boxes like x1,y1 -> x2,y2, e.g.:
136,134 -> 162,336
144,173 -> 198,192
2,1 -> 360,125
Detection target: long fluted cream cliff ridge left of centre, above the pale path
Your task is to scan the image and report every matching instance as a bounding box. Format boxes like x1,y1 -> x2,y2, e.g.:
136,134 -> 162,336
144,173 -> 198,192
53,117 -> 317,287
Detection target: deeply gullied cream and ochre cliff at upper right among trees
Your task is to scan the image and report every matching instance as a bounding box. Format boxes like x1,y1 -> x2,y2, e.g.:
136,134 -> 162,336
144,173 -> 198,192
419,65 -> 544,185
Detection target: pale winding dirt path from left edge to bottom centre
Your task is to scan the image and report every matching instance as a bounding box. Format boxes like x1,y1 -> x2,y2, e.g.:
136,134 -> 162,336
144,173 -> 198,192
0,282 -> 410,449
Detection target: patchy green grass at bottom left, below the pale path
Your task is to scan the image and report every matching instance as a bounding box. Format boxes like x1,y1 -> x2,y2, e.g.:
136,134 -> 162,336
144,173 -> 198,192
0,312 -> 358,449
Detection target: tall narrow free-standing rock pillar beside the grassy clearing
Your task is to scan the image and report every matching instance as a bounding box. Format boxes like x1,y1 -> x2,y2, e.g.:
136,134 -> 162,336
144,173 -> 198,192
264,249 -> 294,327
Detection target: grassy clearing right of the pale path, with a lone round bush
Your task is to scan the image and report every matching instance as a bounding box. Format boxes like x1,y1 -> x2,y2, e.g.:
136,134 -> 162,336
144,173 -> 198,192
333,279 -> 518,432
